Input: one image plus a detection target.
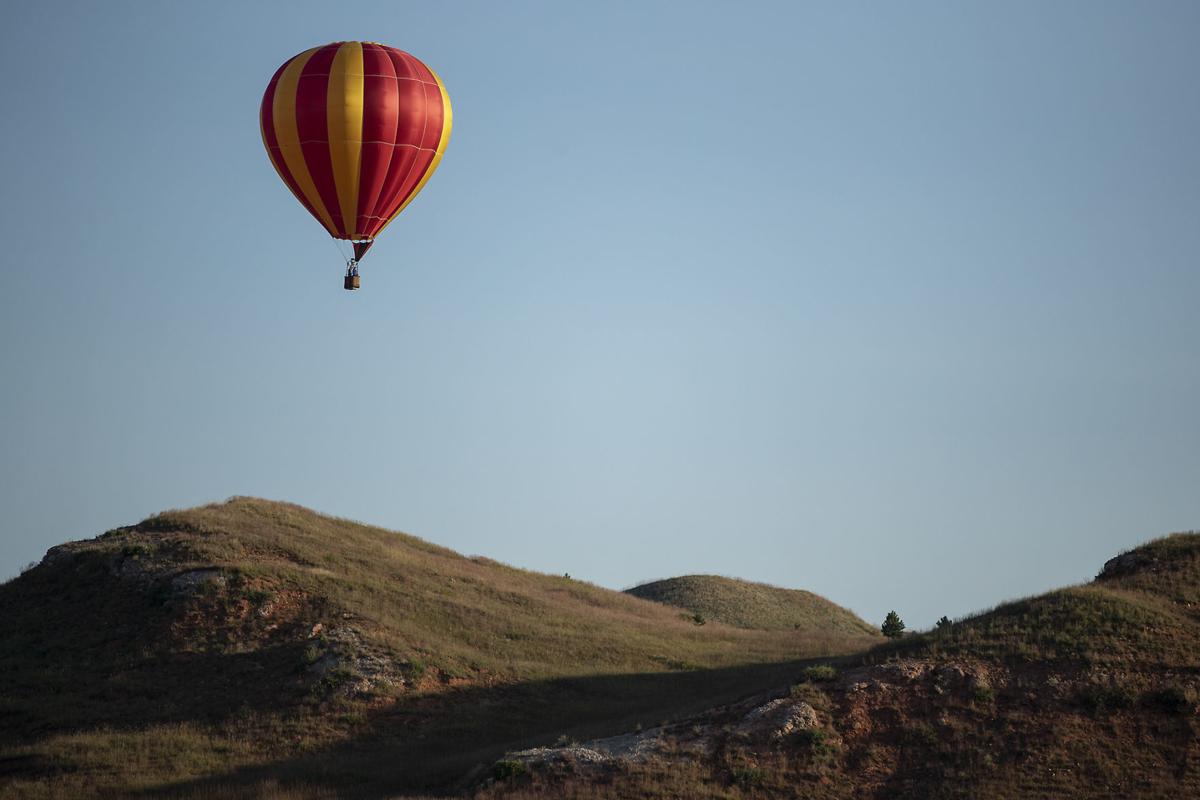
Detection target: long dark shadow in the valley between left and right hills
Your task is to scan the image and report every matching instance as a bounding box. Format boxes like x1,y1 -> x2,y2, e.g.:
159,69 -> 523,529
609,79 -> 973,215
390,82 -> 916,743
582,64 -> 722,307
133,658 -> 844,798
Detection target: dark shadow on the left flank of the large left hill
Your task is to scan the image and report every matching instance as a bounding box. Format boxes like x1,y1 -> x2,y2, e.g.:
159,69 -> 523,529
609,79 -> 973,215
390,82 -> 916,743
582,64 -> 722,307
0,565 -> 324,746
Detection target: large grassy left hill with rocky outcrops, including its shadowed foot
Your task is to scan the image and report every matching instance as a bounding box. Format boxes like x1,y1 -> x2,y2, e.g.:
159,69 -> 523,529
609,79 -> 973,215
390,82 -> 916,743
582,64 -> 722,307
0,498 -> 872,798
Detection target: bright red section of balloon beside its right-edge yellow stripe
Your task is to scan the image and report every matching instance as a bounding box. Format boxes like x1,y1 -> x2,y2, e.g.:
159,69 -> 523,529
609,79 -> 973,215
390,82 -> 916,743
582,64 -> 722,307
370,48 -> 443,236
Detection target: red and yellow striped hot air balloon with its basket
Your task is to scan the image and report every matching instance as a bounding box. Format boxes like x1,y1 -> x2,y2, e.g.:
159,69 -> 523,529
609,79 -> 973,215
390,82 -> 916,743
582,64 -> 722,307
259,42 -> 451,289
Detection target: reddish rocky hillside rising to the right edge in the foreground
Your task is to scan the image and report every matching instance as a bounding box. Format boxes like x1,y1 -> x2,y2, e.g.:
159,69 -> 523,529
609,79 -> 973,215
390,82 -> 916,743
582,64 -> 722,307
479,534 -> 1200,800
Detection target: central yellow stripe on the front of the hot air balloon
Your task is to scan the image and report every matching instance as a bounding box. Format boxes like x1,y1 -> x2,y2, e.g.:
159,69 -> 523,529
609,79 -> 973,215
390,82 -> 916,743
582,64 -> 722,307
325,42 -> 364,239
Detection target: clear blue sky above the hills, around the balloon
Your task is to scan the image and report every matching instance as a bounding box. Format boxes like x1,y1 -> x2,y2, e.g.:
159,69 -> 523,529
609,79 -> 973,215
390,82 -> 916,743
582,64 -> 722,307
0,0 -> 1200,627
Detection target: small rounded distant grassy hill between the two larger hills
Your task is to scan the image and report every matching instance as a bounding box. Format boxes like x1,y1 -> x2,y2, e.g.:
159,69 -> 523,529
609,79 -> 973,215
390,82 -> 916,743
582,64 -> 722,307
625,575 -> 880,636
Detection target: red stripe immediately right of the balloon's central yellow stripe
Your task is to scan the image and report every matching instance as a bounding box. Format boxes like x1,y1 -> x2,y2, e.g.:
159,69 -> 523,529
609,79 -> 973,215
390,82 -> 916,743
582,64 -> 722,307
355,43 -> 400,236
